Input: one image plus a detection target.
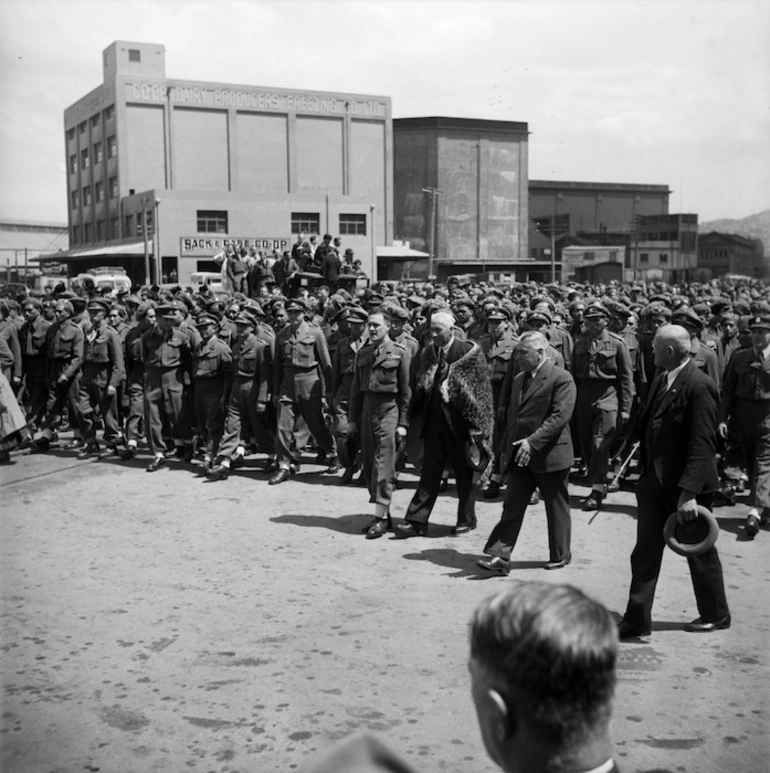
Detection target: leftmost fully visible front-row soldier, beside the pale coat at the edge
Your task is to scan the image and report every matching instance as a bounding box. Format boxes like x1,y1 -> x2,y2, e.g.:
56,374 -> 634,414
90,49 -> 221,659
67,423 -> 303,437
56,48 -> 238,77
32,300 -> 85,453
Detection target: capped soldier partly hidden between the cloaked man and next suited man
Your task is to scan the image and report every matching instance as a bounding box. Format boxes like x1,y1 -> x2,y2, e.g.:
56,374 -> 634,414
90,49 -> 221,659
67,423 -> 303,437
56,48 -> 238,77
479,306 -> 518,499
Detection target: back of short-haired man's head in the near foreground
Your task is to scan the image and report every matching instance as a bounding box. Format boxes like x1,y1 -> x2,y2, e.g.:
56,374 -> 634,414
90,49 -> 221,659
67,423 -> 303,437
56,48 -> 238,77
469,582 -> 618,771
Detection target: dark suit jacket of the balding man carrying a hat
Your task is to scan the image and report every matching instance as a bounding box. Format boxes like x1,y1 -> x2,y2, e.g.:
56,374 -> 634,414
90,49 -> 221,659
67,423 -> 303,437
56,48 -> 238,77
638,361 -> 719,495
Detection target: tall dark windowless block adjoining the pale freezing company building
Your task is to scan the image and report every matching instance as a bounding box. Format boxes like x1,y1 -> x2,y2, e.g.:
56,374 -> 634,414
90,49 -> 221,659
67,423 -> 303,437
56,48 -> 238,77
390,117 -> 529,279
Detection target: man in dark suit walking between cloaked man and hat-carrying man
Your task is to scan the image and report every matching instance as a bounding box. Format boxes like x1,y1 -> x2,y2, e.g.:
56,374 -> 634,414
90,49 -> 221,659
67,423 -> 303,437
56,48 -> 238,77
478,332 -> 576,574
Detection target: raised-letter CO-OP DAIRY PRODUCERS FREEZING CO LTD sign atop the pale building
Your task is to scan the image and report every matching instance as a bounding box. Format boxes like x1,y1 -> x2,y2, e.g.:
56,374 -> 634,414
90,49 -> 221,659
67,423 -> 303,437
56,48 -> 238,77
126,83 -> 387,118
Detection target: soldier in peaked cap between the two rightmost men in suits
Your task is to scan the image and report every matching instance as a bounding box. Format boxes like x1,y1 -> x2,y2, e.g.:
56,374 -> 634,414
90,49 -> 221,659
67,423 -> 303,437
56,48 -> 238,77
572,303 -> 634,510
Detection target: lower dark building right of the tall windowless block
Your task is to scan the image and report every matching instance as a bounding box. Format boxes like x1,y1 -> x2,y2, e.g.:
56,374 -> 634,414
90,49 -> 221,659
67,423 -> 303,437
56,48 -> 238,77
528,180 -> 671,280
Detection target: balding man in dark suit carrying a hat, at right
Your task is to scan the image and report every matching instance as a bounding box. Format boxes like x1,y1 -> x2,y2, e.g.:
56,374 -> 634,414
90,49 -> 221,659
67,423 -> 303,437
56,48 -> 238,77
619,325 -> 730,639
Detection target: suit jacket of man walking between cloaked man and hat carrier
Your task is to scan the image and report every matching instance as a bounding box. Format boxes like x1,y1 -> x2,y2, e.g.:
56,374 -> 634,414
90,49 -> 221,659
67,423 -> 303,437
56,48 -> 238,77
503,360 -> 577,472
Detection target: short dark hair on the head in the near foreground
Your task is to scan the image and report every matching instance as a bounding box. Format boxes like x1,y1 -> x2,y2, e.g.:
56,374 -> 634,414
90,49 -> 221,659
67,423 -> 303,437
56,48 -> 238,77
470,582 -> 618,746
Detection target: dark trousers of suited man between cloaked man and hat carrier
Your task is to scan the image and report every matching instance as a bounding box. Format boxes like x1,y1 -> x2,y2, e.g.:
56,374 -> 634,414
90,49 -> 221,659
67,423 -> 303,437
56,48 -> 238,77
484,464 -> 572,561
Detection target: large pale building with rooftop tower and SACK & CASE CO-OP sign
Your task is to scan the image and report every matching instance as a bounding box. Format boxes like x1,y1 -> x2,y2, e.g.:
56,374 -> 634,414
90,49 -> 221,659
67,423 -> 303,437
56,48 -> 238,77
56,41 -> 393,283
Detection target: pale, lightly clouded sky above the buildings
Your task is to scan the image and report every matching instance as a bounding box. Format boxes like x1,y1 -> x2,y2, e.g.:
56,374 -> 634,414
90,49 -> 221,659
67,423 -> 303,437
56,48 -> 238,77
0,0 -> 770,224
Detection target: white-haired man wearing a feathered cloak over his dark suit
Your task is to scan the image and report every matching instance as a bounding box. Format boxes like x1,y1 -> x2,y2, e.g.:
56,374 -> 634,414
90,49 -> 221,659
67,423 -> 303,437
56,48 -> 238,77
395,311 -> 494,539
